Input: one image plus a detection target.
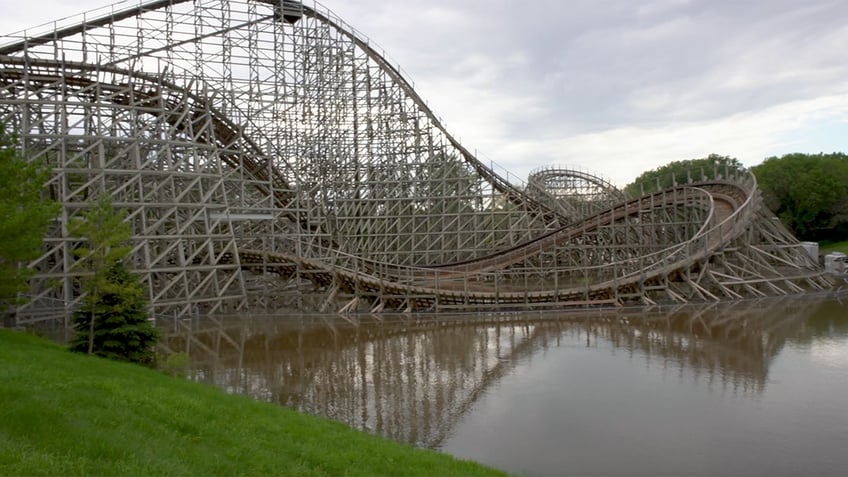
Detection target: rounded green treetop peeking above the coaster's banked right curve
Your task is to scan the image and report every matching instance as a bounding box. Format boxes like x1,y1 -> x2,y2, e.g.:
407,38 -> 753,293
624,154 -> 745,197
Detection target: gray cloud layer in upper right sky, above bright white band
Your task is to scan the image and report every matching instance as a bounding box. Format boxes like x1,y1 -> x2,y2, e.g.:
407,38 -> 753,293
338,0 -> 848,133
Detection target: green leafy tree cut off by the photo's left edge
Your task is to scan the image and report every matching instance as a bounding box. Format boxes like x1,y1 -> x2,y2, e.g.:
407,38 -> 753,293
0,124 -> 59,310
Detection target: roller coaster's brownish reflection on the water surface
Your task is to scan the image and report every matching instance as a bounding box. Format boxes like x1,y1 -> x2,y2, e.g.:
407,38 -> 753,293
157,298 -> 848,448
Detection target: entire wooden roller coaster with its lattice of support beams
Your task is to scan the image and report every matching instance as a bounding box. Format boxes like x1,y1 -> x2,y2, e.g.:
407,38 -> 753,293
0,0 -> 828,322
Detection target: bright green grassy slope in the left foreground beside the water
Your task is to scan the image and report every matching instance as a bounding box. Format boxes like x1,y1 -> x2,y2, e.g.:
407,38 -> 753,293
0,330 -> 504,476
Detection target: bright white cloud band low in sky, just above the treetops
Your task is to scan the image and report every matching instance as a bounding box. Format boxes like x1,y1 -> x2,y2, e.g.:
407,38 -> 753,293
486,94 -> 848,186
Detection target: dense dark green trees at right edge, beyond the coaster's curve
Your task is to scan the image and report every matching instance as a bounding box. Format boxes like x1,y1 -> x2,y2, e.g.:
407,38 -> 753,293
752,153 -> 848,240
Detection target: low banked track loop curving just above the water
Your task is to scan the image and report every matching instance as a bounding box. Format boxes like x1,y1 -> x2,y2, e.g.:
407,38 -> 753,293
234,177 -> 752,307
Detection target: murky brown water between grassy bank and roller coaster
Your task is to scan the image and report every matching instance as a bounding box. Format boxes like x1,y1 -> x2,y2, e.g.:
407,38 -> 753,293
162,297 -> 848,475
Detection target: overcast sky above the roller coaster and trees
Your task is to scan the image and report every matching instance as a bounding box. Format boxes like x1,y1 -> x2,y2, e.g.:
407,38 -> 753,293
0,0 -> 848,186
